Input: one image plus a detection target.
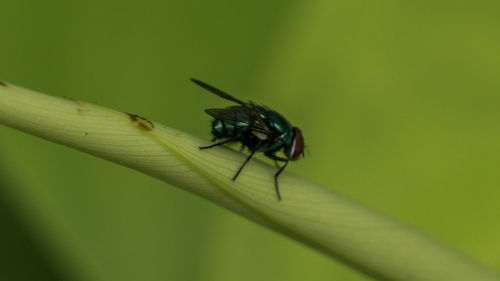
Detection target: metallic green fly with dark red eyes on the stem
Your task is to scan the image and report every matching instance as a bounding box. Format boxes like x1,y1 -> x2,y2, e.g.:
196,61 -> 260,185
191,78 -> 304,200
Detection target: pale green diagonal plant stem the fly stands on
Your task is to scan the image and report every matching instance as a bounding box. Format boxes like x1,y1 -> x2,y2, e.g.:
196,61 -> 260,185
0,82 -> 500,281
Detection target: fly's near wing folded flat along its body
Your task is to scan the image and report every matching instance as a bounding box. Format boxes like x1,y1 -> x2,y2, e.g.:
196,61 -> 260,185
205,106 -> 272,140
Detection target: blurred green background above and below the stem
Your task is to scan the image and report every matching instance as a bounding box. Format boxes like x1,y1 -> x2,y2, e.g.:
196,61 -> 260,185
0,0 -> 500,281
